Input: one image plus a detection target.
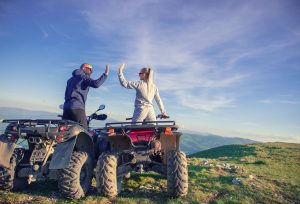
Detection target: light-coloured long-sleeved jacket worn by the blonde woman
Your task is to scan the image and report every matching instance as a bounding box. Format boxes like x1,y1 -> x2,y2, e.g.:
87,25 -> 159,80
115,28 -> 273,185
119,73 -> 166,114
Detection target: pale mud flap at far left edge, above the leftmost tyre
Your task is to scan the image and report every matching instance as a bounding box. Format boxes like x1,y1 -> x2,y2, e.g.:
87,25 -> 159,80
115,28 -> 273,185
0,141 -> 17,168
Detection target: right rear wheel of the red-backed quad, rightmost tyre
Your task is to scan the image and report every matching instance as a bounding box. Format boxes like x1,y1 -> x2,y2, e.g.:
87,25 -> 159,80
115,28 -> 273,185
167,151 -> 188,197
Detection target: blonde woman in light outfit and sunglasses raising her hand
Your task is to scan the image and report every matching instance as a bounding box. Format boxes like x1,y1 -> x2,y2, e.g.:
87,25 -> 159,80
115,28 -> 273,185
119,64 -> 167,122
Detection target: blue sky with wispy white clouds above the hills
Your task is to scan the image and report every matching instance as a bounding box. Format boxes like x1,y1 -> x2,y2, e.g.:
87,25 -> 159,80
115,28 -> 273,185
0,0 -> 300,143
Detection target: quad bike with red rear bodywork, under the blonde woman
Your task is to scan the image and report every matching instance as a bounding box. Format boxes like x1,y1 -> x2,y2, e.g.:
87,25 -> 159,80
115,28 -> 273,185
96,115 -> 188,197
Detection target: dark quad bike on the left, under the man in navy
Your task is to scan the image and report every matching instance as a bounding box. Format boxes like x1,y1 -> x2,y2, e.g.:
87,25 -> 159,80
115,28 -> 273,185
0,105 -> 106,199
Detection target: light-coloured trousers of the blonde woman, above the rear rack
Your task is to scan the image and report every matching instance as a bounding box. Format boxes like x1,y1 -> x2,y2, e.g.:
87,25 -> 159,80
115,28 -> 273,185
132,106 -> 156,122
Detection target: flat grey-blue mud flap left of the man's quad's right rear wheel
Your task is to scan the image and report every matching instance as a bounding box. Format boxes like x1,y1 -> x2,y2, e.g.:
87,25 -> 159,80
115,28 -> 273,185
49,137 -> 76,169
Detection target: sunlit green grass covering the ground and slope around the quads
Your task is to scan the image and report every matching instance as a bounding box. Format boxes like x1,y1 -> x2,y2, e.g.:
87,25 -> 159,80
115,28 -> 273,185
0,143 -> 300,204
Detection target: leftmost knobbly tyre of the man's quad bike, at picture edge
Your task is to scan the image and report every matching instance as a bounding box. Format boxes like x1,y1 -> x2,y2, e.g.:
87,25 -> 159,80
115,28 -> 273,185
0,149 -> 28,191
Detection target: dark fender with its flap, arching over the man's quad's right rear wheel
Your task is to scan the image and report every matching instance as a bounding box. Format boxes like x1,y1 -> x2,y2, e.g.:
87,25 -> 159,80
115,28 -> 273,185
49,131 -> 95,169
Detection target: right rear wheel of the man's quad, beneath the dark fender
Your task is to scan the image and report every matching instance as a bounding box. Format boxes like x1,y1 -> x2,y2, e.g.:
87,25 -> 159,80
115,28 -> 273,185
58,151 -> 93,199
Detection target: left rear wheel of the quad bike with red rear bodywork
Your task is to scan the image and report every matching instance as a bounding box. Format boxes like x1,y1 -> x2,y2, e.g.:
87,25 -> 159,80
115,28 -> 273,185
96,153 -> 122,197
